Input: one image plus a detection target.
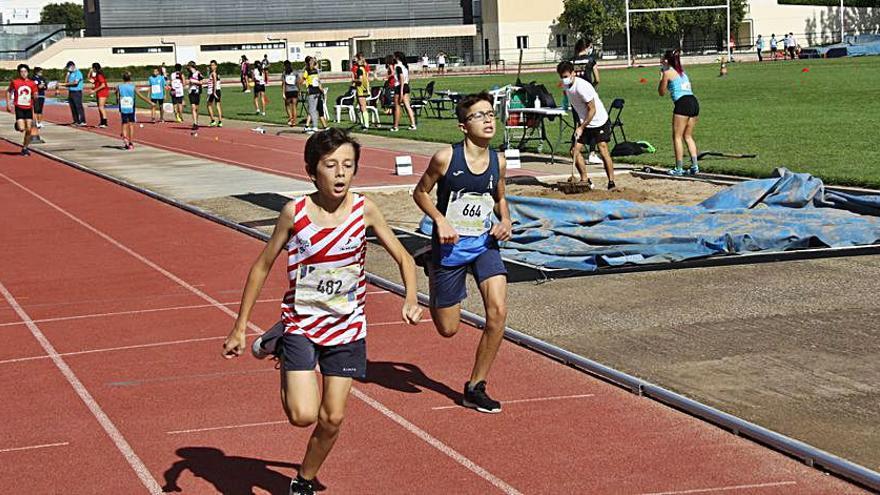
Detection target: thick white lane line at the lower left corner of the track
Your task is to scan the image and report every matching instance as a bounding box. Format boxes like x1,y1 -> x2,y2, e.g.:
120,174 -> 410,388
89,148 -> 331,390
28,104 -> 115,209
0,280 -> 162,494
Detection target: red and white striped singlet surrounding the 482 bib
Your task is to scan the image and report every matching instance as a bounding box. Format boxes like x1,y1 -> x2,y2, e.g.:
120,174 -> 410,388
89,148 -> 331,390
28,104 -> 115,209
281,194 -> 367,346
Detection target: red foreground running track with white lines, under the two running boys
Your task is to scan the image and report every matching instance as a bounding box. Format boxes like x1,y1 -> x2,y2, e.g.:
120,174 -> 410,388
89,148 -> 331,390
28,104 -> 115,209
0,143 -> 861,495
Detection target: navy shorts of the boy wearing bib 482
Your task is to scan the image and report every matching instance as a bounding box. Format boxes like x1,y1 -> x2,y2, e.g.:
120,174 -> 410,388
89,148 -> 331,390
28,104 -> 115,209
281,333 -> 367,378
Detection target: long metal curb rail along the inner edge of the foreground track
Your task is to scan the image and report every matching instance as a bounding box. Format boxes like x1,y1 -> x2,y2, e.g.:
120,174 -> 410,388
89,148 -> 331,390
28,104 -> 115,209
12,137 -> 880,493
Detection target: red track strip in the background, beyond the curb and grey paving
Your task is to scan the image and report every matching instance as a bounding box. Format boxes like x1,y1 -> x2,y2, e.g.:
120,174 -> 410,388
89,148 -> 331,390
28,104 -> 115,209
44,104 -> 552,187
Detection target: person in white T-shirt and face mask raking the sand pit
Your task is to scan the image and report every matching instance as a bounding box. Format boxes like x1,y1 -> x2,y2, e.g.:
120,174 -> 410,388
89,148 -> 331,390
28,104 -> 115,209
556,62 -> 616,190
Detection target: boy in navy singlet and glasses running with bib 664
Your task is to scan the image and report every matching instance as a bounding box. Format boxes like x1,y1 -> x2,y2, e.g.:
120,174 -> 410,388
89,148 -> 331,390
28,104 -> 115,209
413,92 -> 511,413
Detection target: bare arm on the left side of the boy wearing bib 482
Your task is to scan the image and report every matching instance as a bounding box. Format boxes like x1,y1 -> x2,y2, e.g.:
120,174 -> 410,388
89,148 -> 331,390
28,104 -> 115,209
223,201 -> 296,359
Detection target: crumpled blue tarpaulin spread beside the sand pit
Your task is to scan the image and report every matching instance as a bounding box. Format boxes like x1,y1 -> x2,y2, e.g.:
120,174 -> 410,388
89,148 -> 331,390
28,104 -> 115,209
422,169 -> 880,271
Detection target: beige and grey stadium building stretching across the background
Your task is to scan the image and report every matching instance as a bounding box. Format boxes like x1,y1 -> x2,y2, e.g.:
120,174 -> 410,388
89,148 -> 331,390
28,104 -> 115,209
0,0 -> 880,71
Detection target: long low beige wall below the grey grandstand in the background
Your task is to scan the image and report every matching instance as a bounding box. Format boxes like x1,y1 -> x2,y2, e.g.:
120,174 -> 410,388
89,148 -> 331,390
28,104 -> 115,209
15,24 -> 476,71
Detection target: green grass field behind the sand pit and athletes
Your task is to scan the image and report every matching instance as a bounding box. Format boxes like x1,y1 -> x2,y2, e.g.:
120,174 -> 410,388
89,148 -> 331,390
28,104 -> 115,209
208,57 -> 880,187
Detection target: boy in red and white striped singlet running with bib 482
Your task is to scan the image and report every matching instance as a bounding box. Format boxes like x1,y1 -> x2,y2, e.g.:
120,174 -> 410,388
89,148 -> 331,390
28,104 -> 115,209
223,128 -> 422,495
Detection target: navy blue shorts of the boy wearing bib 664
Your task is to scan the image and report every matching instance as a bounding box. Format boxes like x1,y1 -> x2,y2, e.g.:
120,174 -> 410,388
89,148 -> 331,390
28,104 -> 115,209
428,248 -> 507,308
